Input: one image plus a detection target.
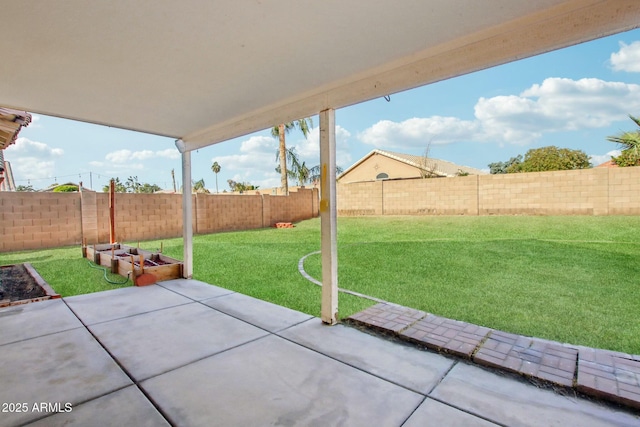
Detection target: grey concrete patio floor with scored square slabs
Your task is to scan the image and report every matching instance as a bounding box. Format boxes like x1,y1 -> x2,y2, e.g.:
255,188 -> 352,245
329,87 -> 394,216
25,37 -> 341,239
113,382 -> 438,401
0,280 -> 640,426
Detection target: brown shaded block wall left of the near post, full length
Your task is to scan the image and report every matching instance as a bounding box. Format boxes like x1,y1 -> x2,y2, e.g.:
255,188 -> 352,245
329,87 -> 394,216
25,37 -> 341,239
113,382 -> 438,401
0,189 -> 319,252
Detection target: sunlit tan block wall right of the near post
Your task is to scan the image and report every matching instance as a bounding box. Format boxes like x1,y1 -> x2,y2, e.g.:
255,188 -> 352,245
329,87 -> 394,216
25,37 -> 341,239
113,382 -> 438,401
337,167 -> 640,216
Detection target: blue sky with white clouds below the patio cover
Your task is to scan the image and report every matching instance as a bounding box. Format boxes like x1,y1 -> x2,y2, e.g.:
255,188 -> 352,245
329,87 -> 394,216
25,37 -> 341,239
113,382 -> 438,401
5,30 -> 640,192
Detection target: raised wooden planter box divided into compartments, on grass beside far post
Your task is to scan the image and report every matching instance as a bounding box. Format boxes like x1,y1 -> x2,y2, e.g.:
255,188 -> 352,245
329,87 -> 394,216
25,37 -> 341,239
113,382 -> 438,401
82,243 -> 183,286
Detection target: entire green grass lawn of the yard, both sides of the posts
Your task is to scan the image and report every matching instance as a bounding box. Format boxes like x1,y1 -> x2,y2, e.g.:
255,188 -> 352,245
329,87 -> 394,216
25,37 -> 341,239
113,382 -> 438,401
0,216 -> 640,354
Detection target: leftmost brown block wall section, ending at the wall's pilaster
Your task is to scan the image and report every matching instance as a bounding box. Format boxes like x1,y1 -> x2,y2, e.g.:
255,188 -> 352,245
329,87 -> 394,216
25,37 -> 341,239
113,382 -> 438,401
0,192 -> 82,252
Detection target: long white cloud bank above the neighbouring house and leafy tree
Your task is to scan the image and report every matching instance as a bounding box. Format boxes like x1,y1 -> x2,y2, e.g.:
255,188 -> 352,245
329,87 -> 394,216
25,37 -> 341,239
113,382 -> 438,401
358,78 -> 640,148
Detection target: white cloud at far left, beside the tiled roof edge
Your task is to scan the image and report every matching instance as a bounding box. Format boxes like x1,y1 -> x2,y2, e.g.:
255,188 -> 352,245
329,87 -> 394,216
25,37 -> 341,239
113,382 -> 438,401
4,137 -> 64,180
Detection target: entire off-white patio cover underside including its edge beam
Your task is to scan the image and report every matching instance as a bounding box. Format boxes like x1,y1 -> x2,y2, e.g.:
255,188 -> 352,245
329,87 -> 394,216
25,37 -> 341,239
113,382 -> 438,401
0,0 -> 640,150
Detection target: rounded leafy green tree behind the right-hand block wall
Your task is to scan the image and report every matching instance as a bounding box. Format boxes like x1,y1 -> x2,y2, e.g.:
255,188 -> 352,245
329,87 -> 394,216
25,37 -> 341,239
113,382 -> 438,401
489,146 -> 591,173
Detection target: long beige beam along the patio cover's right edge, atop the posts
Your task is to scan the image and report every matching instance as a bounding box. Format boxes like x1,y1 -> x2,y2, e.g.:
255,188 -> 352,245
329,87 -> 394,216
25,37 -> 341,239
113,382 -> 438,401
178,0 -> 640,152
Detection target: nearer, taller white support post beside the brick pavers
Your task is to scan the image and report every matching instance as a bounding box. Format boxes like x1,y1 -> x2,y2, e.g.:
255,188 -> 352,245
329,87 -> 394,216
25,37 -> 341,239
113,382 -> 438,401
320,109 -> 338,325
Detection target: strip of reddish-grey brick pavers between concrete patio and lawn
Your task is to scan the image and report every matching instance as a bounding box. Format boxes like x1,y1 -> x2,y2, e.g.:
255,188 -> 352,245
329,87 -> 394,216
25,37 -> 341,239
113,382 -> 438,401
345,303 -> 640,409
